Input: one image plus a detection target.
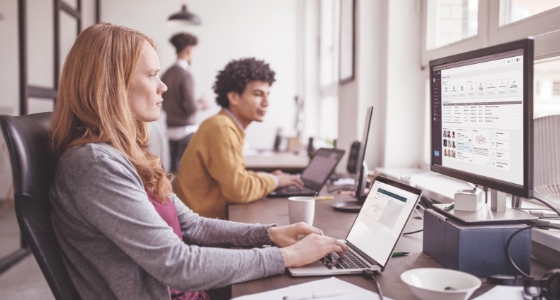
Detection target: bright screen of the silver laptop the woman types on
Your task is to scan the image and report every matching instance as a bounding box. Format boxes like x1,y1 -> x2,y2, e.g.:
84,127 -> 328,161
346,181 -> 418,264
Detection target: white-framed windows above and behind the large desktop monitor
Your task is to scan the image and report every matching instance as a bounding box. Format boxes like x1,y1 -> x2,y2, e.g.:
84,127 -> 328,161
419,0 -> 560,167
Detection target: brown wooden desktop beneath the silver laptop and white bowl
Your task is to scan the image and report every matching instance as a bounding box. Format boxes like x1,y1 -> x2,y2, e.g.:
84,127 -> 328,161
229,195 -> 549,299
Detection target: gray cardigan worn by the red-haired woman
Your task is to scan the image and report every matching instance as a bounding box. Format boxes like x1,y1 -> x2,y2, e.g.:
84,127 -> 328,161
50,144 -> 284,299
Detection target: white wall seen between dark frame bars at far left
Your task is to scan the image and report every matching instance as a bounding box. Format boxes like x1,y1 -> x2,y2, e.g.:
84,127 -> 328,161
0,0 -> 95,199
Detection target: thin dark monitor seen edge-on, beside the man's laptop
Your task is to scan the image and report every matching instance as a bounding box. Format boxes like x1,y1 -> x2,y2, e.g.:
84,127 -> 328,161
333,106 -> 373,212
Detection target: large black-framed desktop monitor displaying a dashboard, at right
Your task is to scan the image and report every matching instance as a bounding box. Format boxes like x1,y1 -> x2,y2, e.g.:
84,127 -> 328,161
430,38 -> 533,202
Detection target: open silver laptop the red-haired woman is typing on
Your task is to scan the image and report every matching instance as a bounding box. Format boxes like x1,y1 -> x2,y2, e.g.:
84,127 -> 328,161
288,176 -> 422,276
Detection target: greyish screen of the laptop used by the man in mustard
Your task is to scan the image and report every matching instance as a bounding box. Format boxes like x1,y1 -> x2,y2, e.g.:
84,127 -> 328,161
301,148 -> 344,190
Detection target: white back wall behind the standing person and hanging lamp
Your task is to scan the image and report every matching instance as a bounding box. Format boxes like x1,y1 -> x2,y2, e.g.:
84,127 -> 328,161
101,0 -> 301,149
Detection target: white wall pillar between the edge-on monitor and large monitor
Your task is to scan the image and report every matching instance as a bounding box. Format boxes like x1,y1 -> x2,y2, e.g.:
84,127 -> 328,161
337,0 -> 424,172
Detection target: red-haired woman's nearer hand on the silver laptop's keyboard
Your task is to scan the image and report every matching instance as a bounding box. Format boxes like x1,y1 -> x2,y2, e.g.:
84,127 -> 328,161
280,233 -> 348,267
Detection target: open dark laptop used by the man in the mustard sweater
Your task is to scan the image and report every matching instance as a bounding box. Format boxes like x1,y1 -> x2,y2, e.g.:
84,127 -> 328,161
268,148 -> 344,197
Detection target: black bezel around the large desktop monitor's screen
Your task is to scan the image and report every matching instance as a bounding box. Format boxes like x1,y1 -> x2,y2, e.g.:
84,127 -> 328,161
429,37 -> 534,198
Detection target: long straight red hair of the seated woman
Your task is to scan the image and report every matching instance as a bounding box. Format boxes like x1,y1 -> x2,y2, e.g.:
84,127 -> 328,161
50,23 -> 172,203
